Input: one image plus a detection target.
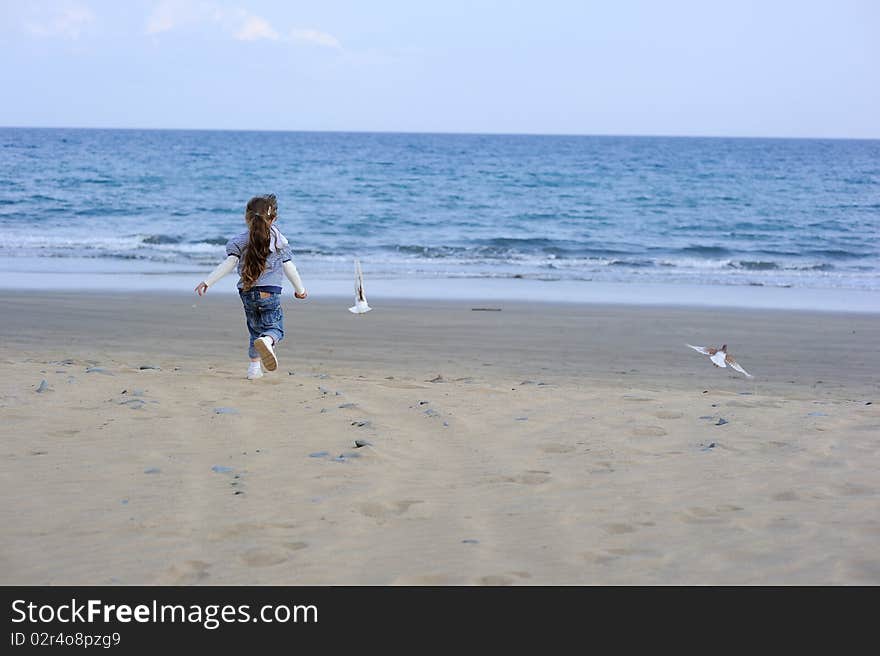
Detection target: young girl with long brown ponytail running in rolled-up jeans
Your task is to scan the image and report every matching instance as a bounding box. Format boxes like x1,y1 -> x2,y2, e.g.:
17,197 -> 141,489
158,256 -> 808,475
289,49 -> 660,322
195,194 -> 308,380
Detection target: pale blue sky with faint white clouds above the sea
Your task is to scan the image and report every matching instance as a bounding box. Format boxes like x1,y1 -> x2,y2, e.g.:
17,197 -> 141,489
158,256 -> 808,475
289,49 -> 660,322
0,0 -> 880,138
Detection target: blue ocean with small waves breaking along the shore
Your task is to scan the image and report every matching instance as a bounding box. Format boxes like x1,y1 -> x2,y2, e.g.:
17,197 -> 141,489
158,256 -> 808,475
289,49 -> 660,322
0,128 -> 880,308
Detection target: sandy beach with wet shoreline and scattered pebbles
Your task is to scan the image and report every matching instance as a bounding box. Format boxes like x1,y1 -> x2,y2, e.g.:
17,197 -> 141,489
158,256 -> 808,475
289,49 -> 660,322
0,291 -> 880,585
